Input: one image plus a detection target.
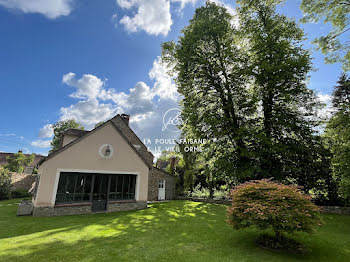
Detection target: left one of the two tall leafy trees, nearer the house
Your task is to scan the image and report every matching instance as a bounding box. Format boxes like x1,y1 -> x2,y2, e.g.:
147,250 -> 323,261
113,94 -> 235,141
162,1 -> 255,180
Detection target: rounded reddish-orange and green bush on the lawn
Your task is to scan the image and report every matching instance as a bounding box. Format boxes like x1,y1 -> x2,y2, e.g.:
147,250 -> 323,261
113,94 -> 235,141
227,179 -> 322,245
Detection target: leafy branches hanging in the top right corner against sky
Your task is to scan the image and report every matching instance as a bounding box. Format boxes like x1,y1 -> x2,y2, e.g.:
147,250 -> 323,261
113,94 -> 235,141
301,0 -> 350,71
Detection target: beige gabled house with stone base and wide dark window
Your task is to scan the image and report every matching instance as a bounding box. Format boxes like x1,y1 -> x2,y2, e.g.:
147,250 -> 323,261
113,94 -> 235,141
32,114 -> 175,216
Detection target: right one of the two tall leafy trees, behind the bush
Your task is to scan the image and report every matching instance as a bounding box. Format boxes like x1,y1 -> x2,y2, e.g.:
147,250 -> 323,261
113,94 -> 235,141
237,0 -> 318,184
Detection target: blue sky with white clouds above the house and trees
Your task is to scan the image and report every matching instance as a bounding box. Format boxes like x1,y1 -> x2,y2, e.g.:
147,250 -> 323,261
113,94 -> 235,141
0,0 -> 341,154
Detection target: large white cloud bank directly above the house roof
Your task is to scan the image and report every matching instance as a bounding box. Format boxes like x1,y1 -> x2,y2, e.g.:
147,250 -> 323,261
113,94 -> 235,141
53,57 -> 180,156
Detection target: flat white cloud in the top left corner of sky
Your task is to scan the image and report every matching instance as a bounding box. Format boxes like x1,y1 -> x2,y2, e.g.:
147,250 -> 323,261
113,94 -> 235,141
0,0 -> 73,19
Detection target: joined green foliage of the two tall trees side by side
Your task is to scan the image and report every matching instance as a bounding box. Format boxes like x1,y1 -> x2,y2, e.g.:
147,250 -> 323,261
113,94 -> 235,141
162,0 -> 323,188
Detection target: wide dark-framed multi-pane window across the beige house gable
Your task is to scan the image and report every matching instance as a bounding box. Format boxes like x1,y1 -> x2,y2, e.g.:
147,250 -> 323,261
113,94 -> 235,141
56,172 -> 136,204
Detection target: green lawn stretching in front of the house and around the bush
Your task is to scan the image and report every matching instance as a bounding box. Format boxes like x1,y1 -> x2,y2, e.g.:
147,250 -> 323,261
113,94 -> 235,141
0,200 -> 350,262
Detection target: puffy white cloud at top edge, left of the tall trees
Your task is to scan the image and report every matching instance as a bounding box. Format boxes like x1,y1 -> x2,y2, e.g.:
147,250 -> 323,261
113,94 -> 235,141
117,0 -> 173,36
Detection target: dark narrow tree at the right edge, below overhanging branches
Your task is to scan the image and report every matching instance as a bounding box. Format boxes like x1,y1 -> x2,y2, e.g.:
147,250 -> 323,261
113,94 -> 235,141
326,74 -> 350,199
